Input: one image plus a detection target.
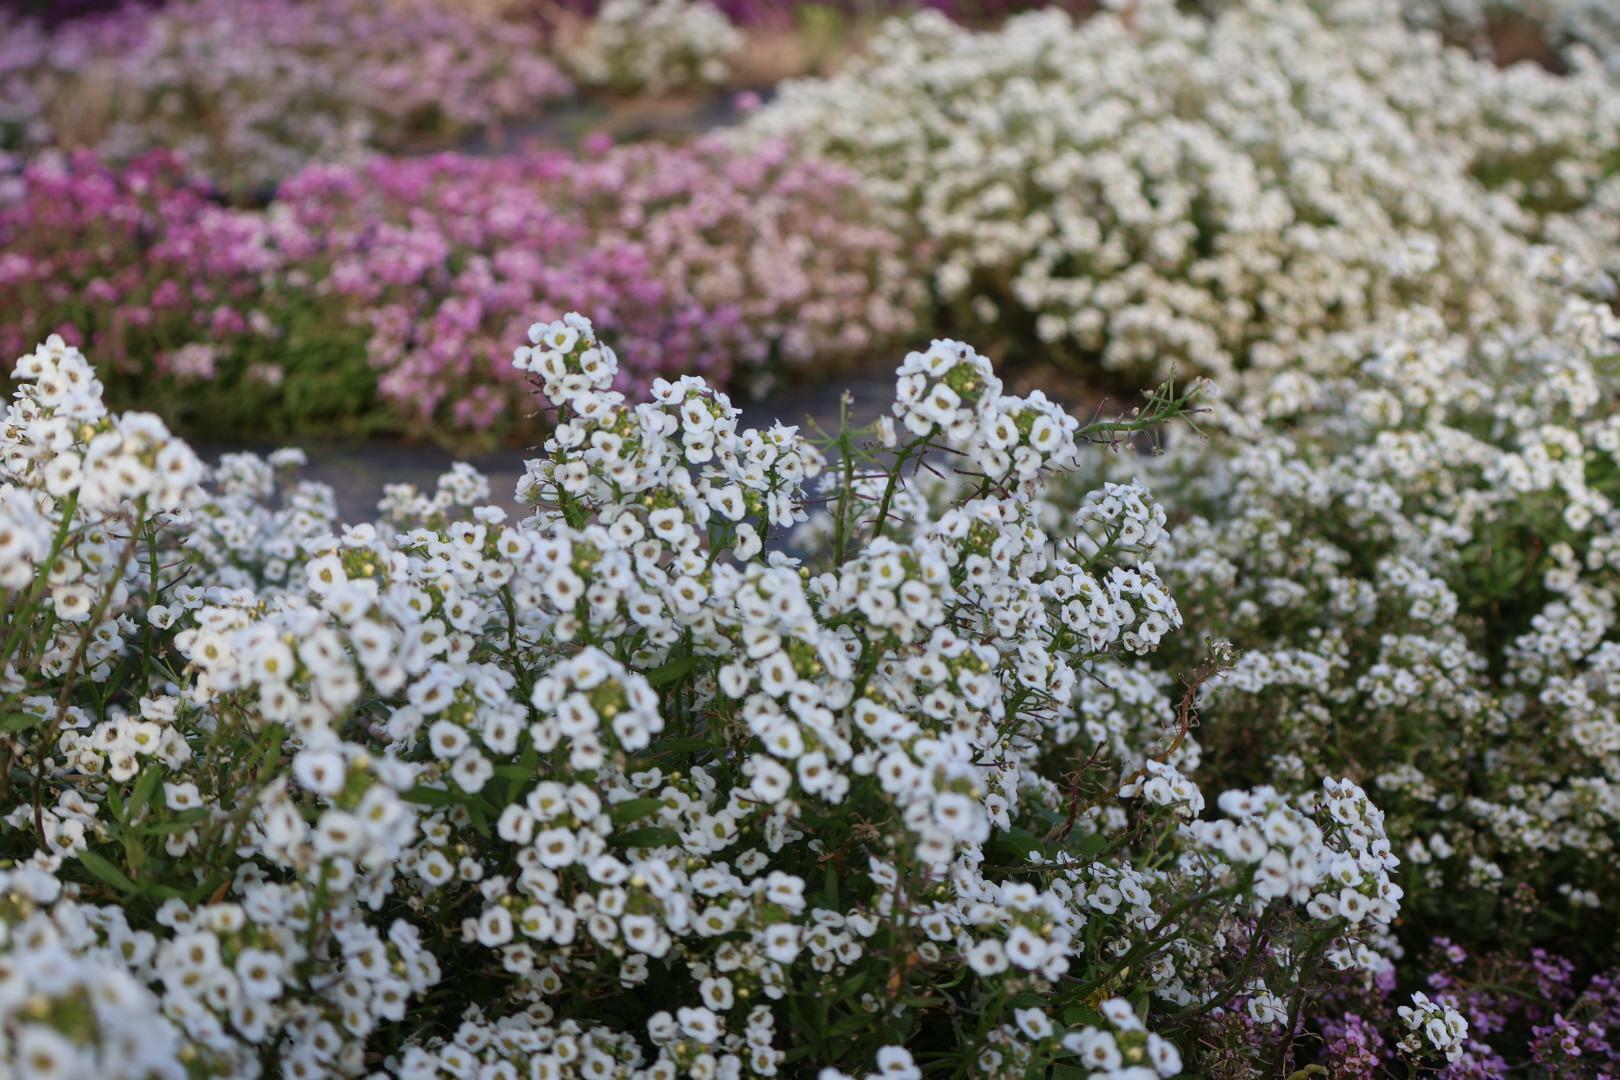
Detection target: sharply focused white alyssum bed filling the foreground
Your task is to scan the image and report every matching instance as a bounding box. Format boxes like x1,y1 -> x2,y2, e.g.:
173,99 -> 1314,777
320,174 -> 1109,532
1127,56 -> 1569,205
0,316 -> 1401,1078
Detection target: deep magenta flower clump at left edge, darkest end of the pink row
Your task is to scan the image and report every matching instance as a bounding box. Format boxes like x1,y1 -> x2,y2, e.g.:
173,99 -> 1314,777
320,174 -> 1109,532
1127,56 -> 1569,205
0,151 -> 332,440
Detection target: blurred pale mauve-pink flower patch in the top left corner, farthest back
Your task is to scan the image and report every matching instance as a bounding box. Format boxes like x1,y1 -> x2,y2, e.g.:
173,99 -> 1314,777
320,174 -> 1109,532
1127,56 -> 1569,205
0,0 -> 570,191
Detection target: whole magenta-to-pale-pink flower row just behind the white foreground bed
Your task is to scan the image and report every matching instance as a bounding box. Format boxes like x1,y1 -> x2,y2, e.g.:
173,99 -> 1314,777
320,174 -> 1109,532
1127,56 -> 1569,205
0,141 -> 923,434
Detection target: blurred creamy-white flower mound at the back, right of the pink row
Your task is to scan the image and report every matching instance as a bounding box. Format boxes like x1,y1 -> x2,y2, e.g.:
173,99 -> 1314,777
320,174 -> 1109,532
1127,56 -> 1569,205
744,0 -> 1620,377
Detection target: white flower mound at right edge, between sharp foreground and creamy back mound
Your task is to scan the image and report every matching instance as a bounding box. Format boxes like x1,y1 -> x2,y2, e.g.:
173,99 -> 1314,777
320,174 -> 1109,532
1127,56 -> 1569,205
1179,301 -> 1620,918
